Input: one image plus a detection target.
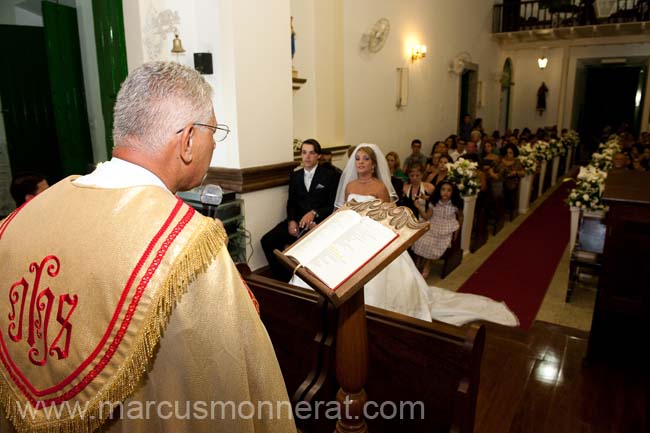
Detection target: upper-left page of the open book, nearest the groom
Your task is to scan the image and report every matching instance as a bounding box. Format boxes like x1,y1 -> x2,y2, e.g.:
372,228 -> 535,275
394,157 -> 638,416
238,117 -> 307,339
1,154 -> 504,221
285,209 -> 361,265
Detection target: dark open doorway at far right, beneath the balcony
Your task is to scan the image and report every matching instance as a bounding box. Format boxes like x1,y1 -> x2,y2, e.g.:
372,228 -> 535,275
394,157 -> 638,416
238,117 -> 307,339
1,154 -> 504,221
574,58 -> 648,161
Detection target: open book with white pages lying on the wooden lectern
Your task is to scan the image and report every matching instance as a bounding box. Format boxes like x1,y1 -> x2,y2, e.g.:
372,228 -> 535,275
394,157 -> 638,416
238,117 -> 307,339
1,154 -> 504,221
284,209 -> 399,290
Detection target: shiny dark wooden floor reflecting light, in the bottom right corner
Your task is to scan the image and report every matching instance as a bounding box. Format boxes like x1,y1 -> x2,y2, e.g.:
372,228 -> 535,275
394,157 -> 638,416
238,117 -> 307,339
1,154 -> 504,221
475,321 -> 650,433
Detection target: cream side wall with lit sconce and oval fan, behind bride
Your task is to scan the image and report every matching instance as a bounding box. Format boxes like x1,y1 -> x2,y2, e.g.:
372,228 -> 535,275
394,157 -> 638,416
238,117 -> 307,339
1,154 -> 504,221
344,0 -> 500,157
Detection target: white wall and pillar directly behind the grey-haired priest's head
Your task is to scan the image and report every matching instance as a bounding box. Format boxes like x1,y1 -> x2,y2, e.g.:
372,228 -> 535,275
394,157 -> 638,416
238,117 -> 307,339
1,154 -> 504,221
125,0 -> 293,269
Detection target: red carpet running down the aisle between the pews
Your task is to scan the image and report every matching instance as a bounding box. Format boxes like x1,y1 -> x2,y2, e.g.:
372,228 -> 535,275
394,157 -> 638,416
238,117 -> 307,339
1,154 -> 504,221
458,182 -> 574,329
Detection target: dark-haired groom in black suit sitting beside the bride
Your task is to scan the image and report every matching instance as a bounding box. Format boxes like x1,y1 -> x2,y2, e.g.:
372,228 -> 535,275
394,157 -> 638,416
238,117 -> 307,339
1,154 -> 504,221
261,138 -> 340,281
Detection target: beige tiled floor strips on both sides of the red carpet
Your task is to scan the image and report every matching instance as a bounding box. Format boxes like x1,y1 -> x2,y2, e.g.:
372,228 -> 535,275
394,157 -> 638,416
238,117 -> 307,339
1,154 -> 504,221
427,182 -> 596,331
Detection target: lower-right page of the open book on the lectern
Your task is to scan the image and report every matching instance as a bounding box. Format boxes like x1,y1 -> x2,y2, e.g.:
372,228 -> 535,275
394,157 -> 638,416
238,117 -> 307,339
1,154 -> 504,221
301,217 -> 398,290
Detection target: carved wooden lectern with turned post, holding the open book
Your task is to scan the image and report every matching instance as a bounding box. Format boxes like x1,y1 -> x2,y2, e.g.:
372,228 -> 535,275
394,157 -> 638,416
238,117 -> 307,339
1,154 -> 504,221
274,200 -> 429,433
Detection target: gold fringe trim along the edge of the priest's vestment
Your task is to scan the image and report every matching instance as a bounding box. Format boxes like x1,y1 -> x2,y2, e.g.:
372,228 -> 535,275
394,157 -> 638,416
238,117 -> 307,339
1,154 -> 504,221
0,218 -> 228,433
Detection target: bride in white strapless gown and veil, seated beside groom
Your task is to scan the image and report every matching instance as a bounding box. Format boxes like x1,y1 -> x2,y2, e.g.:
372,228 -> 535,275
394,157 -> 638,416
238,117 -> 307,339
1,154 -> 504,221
290,143 -> 519,326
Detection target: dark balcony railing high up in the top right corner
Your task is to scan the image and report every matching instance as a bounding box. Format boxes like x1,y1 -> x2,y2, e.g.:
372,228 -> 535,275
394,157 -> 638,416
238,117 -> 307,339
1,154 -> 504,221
492,0 -> 650,33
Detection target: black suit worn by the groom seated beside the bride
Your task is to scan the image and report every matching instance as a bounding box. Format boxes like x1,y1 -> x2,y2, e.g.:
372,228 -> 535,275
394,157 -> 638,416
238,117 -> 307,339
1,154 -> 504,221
261,167 -> 340,281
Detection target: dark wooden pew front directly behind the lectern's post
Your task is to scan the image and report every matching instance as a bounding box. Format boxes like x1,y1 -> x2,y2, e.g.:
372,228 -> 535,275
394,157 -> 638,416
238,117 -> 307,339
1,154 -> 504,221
239,265 -> 485,433
